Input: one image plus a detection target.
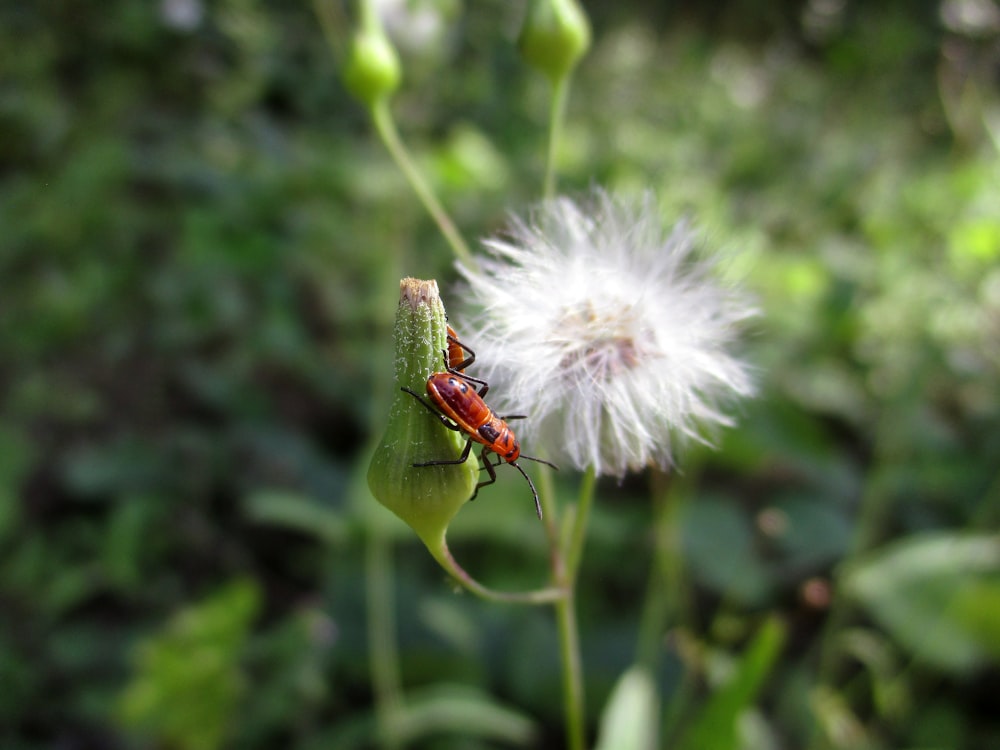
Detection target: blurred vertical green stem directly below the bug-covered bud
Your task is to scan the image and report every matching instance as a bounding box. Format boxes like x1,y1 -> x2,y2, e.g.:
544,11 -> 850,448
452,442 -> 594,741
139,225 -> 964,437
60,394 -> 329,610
365,521 -> 403,750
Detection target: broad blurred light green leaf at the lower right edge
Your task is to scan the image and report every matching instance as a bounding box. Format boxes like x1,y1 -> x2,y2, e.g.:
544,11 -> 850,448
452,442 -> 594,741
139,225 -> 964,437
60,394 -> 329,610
843,533 -> 1000,672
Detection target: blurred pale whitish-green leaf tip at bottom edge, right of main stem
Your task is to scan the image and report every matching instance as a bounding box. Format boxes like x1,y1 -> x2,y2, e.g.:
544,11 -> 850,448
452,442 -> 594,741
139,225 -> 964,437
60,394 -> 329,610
595,666 -> 659,750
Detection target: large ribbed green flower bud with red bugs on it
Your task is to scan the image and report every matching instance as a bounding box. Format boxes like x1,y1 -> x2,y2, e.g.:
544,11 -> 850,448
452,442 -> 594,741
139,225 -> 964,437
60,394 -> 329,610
368,279 -> 479,556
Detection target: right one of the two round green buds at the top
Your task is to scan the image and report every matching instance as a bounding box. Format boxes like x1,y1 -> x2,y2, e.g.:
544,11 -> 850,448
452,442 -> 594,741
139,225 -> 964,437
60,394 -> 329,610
517,0 -> 590,82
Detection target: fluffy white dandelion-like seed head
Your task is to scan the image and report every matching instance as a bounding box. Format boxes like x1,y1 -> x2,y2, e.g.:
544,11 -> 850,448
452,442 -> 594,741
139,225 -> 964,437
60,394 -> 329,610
460,191 -> 755,476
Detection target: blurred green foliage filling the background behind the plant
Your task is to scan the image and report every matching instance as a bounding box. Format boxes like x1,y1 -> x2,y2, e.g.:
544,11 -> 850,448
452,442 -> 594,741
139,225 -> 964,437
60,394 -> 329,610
0,0 -> 1000,750
